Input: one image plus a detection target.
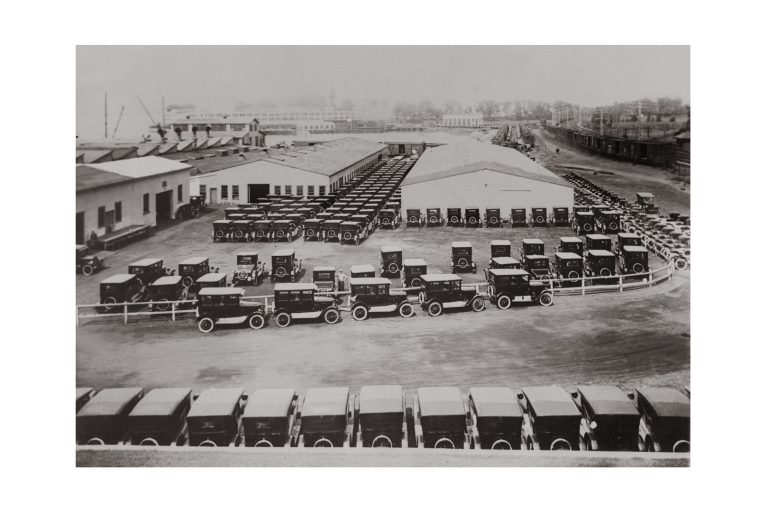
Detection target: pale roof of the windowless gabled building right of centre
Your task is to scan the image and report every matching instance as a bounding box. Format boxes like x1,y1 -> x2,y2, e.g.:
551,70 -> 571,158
402,142 -> 573,188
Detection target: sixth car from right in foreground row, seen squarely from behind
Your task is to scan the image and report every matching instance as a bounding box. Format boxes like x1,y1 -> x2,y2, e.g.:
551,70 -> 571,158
356,385 -> 408,448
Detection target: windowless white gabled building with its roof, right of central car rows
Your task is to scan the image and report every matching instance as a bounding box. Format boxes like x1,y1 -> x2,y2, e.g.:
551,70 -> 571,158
402,142 -> 573,218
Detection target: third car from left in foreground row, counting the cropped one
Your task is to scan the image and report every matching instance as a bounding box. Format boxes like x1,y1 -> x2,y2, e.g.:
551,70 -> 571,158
127,388 -> 192,446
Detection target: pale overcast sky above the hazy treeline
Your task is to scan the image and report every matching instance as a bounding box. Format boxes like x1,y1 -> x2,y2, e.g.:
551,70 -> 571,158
77,46 -> 690,138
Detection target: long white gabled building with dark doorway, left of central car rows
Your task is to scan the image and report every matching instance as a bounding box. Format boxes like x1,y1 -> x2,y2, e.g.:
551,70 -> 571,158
190,137 -> 388,204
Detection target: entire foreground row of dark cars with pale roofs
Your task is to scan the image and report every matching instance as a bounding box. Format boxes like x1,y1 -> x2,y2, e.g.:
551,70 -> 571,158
76,385 -> 690,452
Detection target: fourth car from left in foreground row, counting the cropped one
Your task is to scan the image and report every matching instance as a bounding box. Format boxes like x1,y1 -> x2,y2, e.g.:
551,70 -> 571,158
187,388 -> 245,446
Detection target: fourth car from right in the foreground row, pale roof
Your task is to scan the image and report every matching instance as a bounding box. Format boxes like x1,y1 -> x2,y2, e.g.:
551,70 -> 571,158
469,387 -> 523,450
